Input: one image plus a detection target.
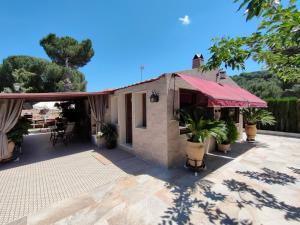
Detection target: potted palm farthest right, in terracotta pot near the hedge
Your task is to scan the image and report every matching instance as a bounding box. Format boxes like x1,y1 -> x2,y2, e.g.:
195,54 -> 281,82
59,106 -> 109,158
242,108 -> 276,141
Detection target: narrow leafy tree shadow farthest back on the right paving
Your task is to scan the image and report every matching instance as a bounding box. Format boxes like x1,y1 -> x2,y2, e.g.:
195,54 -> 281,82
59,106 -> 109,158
236,167 -> 297,185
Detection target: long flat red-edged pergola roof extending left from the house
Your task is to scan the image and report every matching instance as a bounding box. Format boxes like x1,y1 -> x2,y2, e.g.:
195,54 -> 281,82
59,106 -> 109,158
0,90 -> 114,102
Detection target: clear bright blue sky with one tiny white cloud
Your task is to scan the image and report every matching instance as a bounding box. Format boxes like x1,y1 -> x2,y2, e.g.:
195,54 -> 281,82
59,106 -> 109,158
0,0 -> 261,91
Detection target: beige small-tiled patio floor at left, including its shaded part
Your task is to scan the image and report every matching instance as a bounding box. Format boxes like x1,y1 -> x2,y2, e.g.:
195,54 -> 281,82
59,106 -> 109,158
0,134 -> 150,224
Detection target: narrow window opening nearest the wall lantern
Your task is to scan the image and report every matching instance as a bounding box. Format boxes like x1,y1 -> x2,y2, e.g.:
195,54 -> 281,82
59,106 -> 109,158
134,93 -> 147,128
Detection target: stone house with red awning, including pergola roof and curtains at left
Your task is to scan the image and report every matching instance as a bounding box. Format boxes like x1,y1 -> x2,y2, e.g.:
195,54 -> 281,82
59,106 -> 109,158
0,54 -> 266,167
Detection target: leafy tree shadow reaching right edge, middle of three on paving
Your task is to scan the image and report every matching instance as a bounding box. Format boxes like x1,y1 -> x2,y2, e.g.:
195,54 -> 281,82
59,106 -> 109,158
223,179 -> 300,221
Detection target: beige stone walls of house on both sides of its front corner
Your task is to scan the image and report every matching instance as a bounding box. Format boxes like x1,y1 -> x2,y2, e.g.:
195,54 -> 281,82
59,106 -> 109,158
99,74 -> 242,167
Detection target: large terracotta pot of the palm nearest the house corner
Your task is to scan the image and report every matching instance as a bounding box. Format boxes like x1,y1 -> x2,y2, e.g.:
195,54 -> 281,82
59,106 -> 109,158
185,141 -> 205,167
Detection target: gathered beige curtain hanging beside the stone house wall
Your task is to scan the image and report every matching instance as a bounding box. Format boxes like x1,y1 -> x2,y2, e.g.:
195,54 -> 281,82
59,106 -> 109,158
88,95 -> 108,133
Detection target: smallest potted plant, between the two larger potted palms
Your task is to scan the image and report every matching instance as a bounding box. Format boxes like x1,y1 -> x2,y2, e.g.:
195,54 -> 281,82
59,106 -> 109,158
218,119 -> 239,153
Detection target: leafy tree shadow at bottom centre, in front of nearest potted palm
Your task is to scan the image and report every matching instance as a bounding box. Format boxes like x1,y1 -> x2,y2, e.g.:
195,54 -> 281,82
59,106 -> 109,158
160,179 -> 252,225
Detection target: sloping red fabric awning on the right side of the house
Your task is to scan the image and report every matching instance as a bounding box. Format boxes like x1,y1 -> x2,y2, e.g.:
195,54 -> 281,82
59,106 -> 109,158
177,74 -> 267,107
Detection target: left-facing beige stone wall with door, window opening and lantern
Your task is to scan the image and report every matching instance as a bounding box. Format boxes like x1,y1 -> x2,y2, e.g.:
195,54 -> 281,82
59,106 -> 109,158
114,77 -> 168,167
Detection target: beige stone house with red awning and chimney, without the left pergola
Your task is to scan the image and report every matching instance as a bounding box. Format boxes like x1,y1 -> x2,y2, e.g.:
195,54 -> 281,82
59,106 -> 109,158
91,54 -> 266,167
